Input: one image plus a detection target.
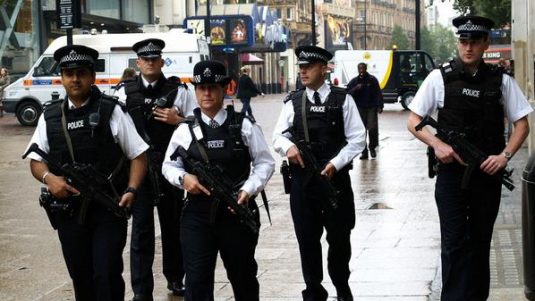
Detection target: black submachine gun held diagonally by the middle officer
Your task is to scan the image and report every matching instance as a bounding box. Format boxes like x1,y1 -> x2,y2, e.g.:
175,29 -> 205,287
171,146 -> 259,234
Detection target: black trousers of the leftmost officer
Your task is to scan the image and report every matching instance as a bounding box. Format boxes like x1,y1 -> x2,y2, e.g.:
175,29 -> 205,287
56,205 -> 128,301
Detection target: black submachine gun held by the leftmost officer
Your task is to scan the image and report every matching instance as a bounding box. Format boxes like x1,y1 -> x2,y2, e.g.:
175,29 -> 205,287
22,143 -> 130,229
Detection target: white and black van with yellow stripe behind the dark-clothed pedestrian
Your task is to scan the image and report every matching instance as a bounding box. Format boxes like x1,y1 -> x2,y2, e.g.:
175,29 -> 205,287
331,50 -> 435,109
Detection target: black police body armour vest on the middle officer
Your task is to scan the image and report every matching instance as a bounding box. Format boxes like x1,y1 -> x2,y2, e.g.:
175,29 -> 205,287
185,106 -> 252,198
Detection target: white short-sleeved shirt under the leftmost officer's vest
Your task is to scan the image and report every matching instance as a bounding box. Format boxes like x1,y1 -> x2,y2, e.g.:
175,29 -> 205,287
26,99 -> 149,161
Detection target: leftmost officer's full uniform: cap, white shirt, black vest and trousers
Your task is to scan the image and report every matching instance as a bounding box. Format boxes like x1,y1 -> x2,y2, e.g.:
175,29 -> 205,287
24,45 -> 148,300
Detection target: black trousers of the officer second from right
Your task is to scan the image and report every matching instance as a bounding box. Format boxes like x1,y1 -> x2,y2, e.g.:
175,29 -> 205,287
290,165 -> 355,301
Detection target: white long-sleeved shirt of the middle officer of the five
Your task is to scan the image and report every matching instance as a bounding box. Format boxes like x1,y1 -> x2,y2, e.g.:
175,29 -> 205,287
162,109 -> 275,196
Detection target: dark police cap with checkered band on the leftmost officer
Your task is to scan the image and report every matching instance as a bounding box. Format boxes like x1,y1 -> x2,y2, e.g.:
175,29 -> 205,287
54,45 -> 98,68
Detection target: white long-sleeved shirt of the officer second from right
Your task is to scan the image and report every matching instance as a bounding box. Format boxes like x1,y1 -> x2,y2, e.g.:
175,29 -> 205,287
273,84 -> 366,170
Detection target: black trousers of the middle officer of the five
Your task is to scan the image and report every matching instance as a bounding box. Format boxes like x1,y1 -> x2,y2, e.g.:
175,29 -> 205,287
180,199 -> 259,301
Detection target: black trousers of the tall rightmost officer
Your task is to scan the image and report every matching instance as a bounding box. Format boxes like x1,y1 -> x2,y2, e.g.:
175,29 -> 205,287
435,164 -> 501,301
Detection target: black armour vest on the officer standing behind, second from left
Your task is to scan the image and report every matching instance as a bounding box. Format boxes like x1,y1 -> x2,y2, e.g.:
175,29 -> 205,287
124,74 -> 180,153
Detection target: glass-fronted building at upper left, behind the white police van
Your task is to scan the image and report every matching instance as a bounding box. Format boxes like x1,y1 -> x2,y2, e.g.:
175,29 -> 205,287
0,0 -> 154,81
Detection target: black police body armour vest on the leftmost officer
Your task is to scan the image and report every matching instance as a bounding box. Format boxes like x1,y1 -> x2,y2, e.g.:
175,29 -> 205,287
43,86 -> 128,191
